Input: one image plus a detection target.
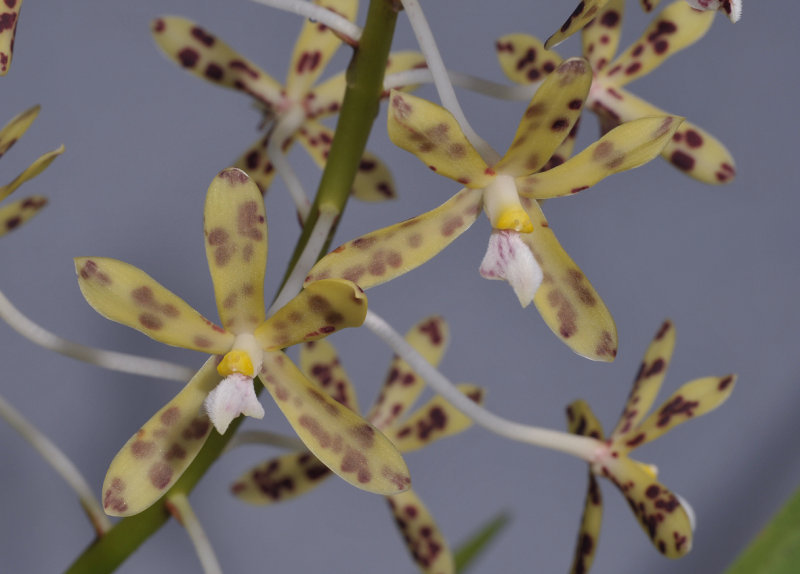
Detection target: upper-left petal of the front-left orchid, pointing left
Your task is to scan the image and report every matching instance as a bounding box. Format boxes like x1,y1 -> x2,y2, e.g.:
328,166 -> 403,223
75,257 -> 234,354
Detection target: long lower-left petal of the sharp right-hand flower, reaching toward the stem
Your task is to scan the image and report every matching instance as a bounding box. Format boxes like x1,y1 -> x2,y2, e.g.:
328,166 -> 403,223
306,188 -> 483,289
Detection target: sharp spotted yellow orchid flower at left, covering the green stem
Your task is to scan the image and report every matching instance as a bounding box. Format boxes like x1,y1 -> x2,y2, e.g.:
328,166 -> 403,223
75,168 -> 410,516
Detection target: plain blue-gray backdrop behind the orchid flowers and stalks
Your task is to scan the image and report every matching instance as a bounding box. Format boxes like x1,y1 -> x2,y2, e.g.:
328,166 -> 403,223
0,0 -> 800,573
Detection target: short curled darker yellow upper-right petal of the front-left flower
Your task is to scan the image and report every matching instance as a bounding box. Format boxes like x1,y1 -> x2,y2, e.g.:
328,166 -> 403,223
254,279 -> 367,351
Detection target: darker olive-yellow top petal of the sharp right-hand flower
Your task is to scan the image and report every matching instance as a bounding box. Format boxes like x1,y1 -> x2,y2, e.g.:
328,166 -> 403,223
493,58 -> 592,177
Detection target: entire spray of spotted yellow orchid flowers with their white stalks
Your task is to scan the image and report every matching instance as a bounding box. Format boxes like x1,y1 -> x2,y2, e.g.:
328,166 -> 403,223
0,0 -> 752,574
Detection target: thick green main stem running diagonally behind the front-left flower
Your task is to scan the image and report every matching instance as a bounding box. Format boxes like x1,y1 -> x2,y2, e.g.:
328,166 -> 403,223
67,0 -> 397,574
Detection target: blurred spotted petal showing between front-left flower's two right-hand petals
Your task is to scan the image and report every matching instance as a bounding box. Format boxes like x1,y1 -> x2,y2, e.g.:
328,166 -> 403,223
300,339 -> 361,413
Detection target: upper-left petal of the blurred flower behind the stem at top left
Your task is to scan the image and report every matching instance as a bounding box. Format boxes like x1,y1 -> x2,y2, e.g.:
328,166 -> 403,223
150,16 -> 283,109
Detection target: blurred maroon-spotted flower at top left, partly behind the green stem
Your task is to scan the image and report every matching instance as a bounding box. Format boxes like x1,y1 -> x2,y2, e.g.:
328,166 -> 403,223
152,0 -> 425,206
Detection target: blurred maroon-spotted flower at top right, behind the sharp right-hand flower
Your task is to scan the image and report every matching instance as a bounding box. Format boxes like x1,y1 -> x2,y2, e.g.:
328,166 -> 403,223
496,0 -> 736,184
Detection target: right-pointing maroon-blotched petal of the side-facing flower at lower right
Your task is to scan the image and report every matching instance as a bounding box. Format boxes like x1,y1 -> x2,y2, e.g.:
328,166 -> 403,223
628,375 -> 736,446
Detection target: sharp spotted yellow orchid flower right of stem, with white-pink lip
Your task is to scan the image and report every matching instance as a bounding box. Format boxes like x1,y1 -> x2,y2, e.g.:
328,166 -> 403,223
306,58 -> 680,361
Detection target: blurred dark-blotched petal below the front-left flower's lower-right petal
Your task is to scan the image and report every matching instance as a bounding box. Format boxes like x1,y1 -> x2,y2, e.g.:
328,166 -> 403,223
231,451 -> 333,506
